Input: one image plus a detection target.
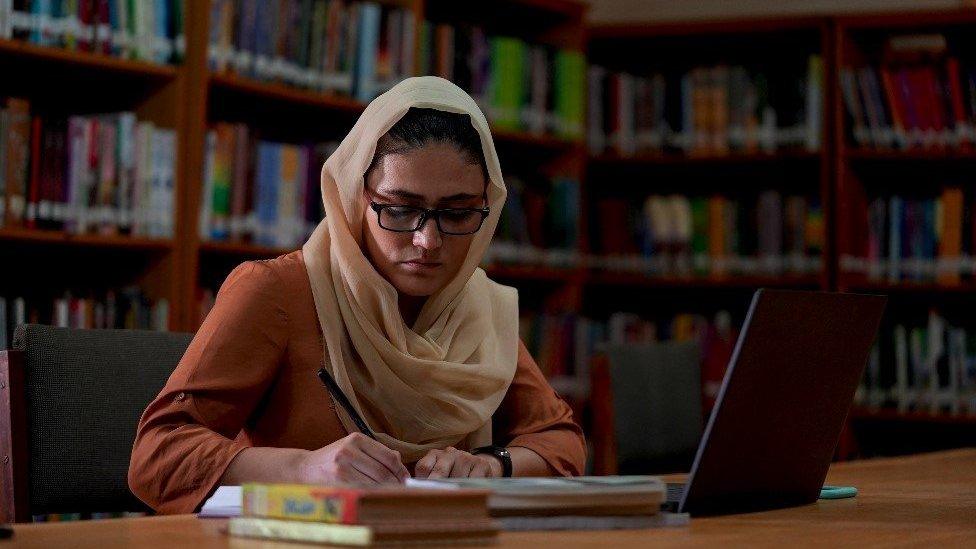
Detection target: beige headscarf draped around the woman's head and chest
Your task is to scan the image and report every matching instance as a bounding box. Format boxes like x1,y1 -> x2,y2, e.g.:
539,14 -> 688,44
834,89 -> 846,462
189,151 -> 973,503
302,76 -> 518,463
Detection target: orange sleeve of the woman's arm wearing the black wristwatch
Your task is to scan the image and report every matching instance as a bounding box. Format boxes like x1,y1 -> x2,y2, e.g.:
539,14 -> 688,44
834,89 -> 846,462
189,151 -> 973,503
492,340 -> 586,476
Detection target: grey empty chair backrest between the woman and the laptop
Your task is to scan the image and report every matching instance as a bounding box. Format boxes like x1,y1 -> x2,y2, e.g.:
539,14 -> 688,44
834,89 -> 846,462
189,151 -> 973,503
604,342 -> 703,474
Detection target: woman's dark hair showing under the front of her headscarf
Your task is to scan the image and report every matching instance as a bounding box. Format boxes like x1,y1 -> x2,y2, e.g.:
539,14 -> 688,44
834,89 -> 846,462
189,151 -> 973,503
364,107 -> 488,184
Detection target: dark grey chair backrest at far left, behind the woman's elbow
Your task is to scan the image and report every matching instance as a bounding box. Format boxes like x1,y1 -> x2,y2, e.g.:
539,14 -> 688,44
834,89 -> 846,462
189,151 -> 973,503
0,324 -> 192,522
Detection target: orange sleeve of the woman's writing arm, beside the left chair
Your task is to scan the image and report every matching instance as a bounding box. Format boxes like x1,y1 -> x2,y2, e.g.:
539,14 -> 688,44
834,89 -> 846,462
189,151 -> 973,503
129,262 -> 288,513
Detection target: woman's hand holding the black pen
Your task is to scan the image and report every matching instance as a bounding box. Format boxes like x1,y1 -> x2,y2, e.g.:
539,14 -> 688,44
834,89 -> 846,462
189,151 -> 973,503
298,433 -> 410,484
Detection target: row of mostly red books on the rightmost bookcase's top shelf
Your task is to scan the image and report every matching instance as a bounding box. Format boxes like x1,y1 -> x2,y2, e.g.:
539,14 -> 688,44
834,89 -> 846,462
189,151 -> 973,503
839,34 -> 976,149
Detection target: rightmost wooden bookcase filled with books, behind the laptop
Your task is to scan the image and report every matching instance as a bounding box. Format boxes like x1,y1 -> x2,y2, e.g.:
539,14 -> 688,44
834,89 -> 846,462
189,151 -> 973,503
831,10 -> 976,457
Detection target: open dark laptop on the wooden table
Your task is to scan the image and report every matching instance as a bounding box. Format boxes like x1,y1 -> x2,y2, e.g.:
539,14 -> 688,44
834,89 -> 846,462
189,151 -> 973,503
665,289 -> 887,516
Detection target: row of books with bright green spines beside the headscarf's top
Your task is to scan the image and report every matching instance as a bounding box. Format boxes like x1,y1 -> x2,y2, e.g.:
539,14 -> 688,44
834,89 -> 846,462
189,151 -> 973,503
418,20 -> 586,140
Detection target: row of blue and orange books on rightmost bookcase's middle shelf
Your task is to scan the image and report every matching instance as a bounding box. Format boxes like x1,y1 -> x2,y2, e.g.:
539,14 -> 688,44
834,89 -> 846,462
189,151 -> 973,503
841,185 -> 976,285
